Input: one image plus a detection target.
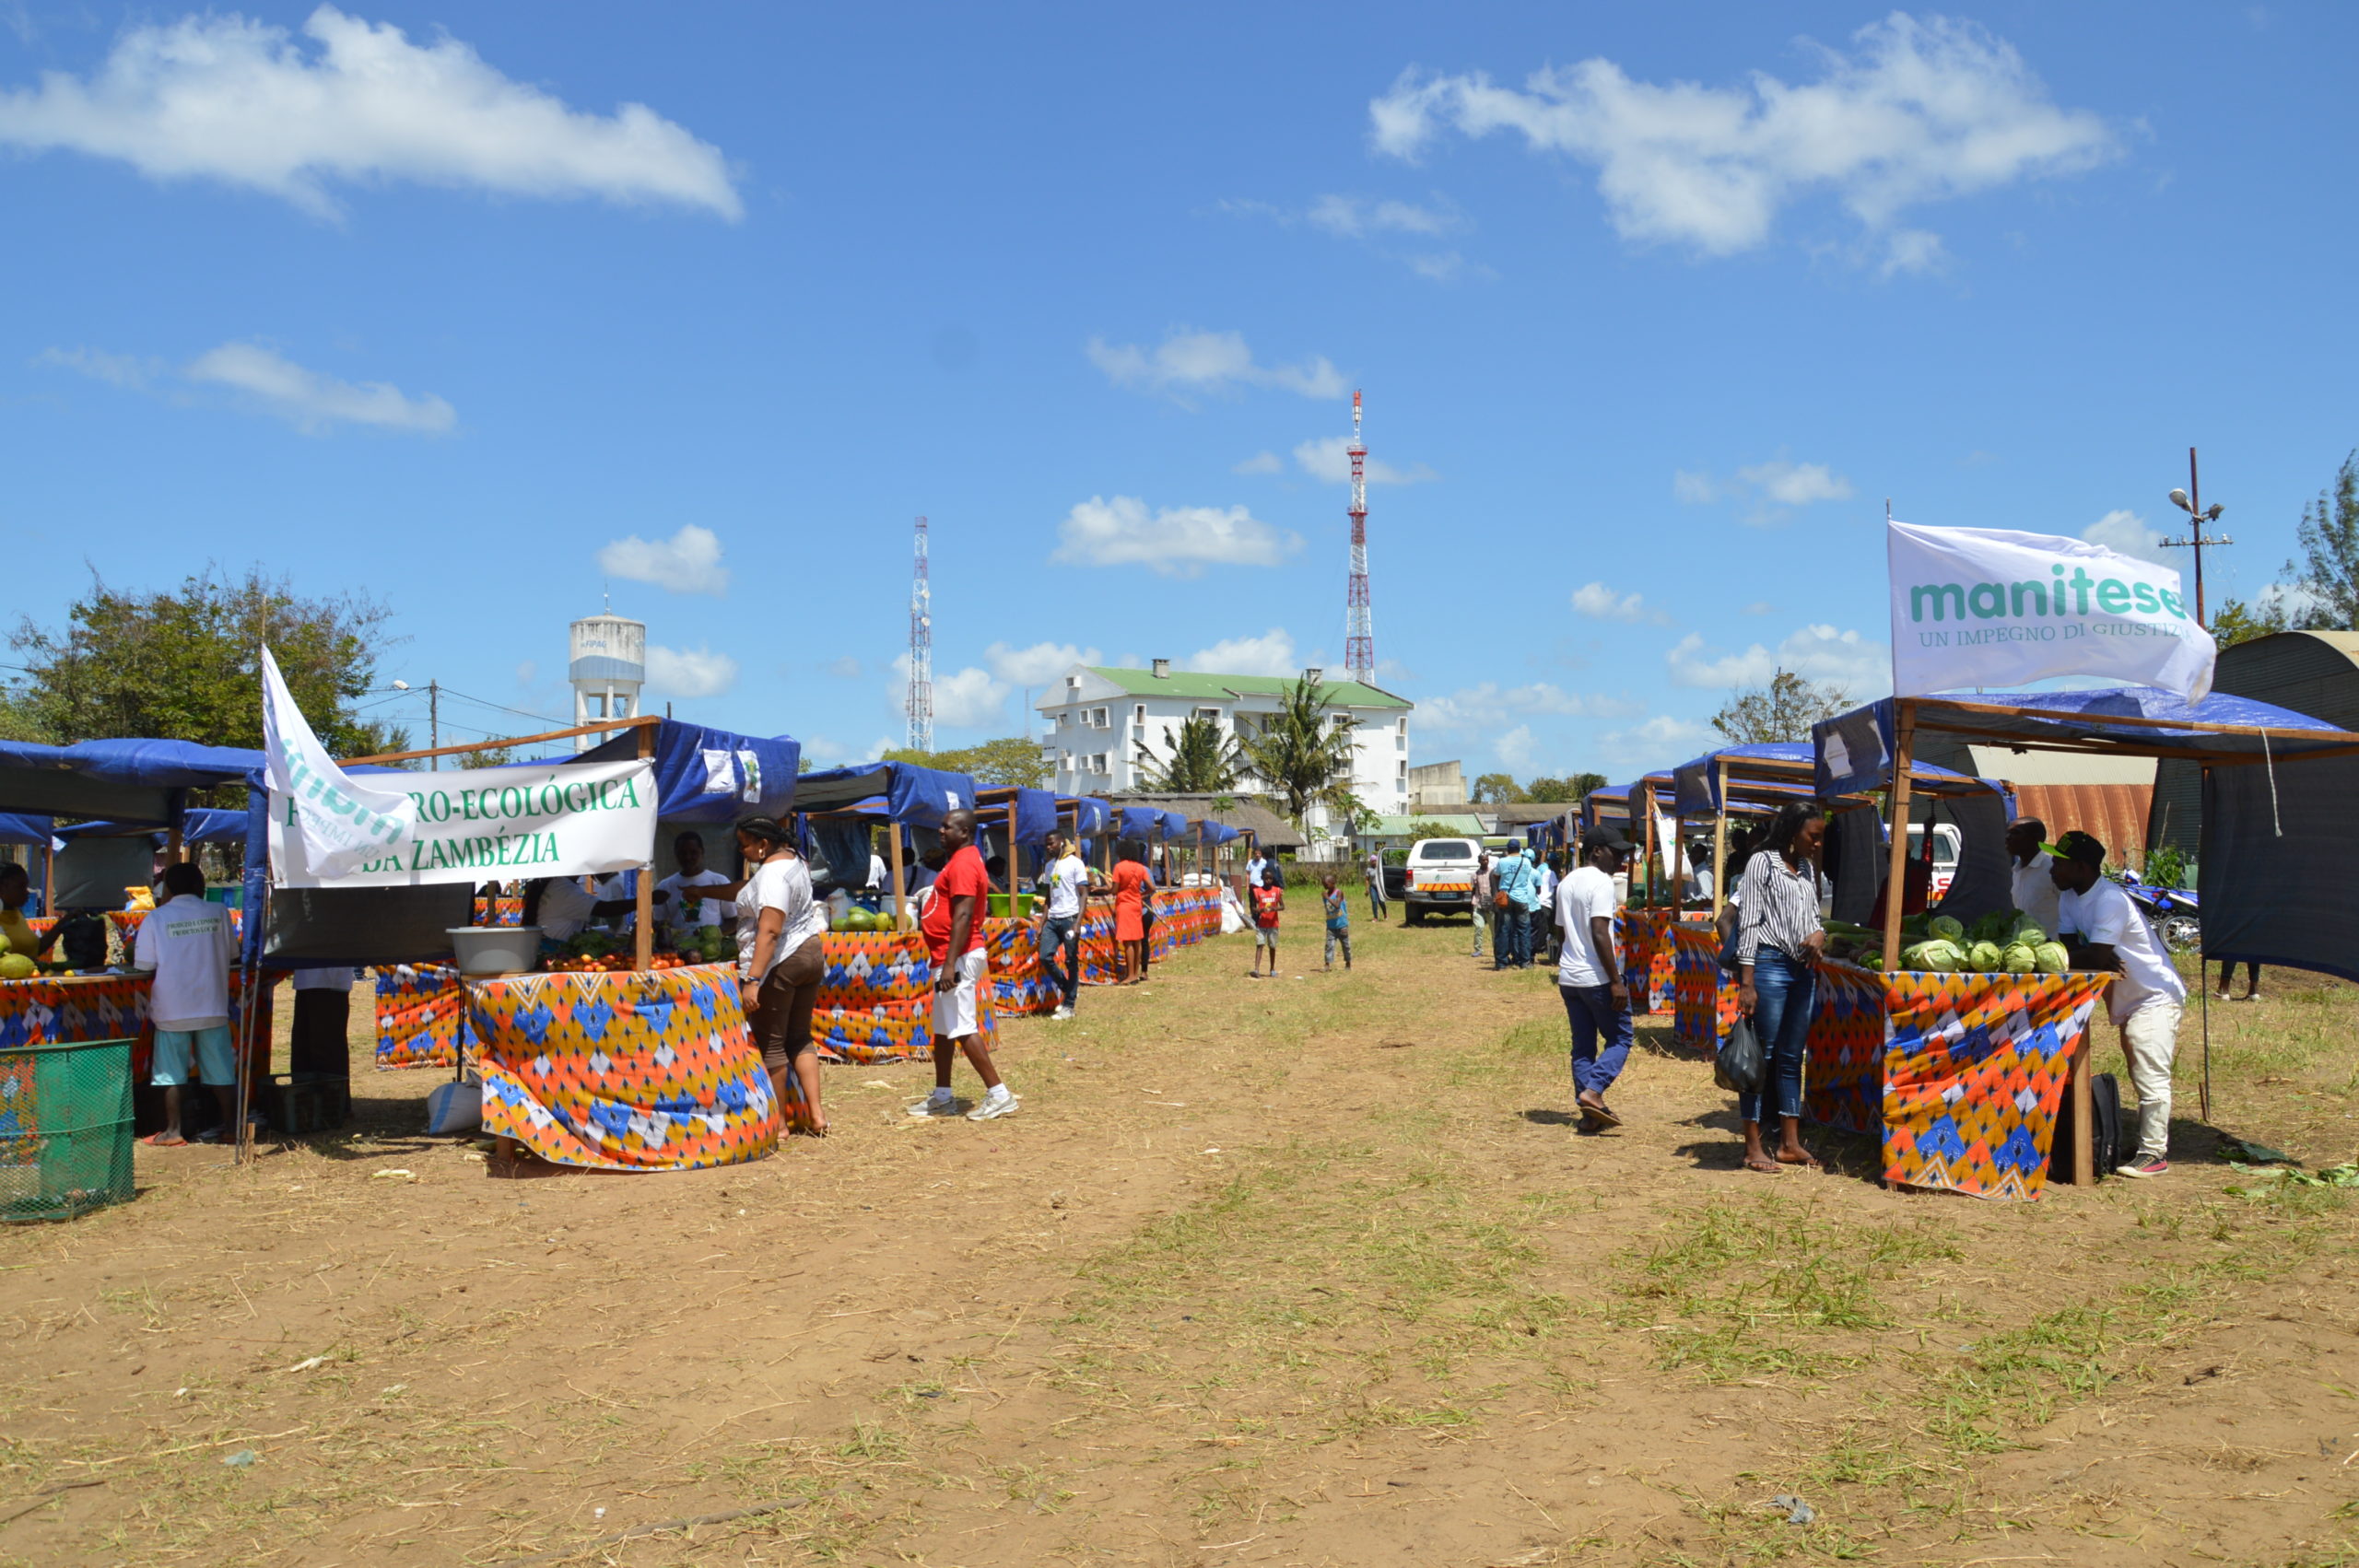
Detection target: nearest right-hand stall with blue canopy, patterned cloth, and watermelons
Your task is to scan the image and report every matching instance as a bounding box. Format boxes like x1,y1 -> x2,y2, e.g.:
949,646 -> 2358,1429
1804,686 -> 2359,1198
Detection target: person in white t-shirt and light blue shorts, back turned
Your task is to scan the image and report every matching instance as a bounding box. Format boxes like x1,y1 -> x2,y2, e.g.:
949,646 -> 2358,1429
132,860 -> 239,1148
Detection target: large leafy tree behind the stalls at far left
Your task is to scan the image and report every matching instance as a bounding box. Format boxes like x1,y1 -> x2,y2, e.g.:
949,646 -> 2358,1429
0,566 -> 410,757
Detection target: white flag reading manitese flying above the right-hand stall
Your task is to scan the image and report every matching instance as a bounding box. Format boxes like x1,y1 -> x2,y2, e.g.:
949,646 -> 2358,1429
1884,523 -> 2217,703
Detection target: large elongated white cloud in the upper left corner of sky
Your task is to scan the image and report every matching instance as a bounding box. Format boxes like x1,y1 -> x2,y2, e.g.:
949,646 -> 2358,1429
0,5 -> 743,219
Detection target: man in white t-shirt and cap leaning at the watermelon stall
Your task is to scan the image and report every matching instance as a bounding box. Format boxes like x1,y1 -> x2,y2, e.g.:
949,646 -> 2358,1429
2048,830 -> 2187,1176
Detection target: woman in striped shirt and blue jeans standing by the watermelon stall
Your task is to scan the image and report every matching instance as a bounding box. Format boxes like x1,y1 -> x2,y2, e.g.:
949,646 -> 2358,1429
1736,802 -> 1825,1172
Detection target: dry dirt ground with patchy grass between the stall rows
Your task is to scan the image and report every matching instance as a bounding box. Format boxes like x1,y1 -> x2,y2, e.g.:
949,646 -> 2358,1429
0,924 -> 2359,1568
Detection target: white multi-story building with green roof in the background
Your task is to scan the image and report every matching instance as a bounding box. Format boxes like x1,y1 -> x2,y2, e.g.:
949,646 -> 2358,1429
1040,658 -> 1413,854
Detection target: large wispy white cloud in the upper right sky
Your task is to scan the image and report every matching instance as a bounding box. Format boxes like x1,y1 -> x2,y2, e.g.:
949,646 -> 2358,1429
1368,12 -> 2118,264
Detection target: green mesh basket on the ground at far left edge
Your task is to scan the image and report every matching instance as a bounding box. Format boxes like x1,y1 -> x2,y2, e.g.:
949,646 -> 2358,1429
0,1040 -> 135,1222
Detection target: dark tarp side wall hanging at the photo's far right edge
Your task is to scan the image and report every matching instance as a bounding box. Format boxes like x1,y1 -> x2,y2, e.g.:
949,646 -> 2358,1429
2201,757 -> 2359,981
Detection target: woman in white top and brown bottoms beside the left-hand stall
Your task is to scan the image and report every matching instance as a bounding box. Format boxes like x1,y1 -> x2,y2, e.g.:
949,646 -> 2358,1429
698,816 -> 828,1137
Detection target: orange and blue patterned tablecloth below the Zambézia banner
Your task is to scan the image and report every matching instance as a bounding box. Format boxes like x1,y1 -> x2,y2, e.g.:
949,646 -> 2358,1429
467,965 -> 780,1169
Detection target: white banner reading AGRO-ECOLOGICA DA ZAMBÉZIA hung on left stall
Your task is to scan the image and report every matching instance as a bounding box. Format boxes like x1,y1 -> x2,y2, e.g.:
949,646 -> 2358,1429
271,759 -> 656,886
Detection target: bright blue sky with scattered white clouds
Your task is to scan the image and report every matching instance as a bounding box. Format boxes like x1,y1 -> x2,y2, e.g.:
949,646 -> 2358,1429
0,0 -> 2359,778
